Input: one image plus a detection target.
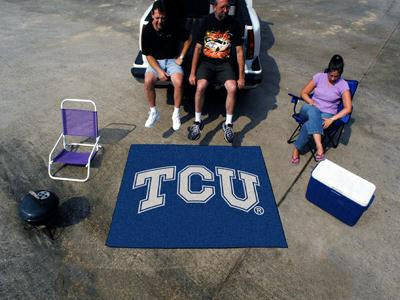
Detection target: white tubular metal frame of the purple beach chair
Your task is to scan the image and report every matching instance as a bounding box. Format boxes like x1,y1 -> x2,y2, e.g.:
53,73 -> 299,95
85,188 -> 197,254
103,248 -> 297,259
48,99 -> 101,182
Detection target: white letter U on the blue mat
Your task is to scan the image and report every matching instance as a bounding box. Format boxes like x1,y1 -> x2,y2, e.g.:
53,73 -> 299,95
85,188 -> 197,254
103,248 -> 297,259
215,167 -> 260,212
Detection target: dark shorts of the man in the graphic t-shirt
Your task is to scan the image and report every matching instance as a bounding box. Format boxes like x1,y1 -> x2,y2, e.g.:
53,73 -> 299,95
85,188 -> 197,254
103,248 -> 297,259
197,61 -> 236,84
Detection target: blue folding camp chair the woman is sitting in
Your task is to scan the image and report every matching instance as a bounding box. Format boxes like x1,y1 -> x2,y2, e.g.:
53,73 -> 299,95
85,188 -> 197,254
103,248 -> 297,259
287,79 -> 358,159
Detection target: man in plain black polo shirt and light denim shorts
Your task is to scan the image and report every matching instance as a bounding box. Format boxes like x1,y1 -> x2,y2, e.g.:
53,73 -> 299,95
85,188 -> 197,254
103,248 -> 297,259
142,1 -> 191,130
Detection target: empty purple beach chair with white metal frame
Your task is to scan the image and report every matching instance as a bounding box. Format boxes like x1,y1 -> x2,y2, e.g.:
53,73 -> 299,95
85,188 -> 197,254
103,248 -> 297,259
48,99 -> 101,182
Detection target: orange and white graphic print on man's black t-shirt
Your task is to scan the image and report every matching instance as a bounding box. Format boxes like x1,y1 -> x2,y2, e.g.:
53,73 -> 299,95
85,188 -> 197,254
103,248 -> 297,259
203,31 -> 232,59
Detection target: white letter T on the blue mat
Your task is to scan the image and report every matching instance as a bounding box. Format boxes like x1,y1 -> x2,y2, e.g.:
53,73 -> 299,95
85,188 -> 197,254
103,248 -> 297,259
133,167 -> 176,213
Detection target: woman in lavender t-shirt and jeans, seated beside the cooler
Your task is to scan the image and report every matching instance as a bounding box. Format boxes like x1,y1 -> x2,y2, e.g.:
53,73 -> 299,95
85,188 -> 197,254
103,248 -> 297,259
291,54 -> 351,164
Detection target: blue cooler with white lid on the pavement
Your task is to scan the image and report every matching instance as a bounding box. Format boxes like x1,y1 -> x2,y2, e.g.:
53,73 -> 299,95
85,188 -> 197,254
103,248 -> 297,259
306,159 -> 376,226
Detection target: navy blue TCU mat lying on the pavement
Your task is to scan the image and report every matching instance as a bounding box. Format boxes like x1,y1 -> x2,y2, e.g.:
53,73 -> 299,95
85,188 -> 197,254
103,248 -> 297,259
106,145 -> 287,248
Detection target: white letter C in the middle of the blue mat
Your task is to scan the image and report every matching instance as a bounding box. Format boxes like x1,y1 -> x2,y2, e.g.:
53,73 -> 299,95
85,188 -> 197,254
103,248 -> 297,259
177,166 -> 215,203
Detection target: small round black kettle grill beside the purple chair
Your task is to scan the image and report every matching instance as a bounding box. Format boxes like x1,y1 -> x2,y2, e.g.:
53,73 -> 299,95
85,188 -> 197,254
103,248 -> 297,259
19,190 -> 59,224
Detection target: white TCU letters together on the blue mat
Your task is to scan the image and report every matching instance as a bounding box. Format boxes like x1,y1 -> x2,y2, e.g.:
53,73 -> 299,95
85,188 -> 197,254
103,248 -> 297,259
133,165 -> 260,213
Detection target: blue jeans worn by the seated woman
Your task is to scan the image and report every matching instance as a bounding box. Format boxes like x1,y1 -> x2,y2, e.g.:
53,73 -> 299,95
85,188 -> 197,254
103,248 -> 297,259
294,104 -> 333,150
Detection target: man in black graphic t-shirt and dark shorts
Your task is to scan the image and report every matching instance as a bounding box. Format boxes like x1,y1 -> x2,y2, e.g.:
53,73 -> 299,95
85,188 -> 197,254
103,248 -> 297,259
188,0 -> 245,143
